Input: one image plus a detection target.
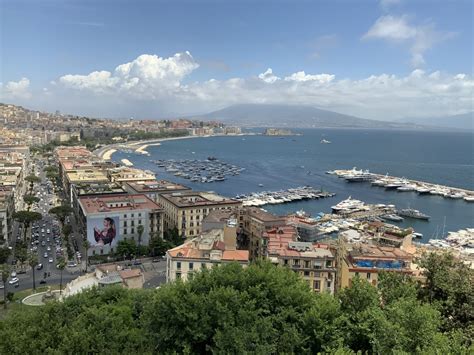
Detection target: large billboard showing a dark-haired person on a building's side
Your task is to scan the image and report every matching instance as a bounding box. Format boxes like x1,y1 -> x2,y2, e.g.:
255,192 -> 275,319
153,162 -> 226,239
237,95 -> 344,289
87,216 -> 120,251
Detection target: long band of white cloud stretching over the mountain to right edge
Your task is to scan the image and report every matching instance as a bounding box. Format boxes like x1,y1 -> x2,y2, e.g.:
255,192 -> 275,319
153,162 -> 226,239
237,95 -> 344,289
49,52 -> 474,119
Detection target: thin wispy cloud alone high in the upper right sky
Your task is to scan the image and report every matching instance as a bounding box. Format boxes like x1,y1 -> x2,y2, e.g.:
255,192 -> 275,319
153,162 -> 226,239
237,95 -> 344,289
362,15 -> 454,67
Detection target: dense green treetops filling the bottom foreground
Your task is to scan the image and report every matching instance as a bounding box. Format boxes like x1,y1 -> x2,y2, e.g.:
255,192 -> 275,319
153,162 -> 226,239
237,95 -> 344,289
0,262 -> 472,354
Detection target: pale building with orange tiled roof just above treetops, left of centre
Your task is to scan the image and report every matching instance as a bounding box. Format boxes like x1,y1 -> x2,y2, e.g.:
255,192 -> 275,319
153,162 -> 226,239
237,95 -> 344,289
166,220 -> 249,282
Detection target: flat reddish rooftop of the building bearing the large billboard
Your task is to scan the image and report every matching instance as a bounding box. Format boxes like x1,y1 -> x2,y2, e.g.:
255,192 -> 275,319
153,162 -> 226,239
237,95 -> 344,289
79,194 -> 161,215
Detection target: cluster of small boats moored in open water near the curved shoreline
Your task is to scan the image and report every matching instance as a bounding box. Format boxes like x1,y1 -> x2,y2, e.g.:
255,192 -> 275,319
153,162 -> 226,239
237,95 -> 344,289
150,156 -> 245,183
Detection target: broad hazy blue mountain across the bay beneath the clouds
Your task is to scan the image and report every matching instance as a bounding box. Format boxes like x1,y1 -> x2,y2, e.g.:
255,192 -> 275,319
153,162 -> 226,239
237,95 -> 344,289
192,104 -> 417,128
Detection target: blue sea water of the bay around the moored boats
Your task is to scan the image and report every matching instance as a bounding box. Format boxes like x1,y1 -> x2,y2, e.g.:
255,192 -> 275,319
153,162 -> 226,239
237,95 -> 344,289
112,129 -> 474,242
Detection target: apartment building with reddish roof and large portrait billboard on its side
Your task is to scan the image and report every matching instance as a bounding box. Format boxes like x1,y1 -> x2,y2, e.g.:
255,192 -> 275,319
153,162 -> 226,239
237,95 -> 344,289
78,194 -> 163,255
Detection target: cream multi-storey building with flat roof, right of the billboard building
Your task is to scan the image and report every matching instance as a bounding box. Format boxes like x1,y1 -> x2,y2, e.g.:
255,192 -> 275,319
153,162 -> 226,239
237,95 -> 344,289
158,191 -> 241,238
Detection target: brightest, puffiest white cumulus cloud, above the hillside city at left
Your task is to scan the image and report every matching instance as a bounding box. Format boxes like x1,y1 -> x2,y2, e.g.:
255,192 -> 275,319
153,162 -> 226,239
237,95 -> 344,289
59,52 -> 199,98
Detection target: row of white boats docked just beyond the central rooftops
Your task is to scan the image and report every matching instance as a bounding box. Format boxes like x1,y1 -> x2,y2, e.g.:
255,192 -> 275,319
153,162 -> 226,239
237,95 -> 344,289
235,186 -> 335,206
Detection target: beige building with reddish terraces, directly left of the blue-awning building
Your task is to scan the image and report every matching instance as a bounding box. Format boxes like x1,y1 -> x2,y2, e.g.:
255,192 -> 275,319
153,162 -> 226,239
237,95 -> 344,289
263,226 -> 336,294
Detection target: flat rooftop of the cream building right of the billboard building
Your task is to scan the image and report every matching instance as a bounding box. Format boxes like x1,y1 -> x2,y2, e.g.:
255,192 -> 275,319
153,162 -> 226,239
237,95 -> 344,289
161,191 -> 240,207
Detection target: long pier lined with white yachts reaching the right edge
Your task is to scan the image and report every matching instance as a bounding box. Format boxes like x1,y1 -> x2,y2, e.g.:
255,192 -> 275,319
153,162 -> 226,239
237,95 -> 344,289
326,168 -> 474,202
